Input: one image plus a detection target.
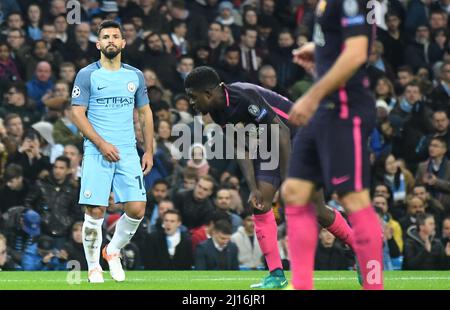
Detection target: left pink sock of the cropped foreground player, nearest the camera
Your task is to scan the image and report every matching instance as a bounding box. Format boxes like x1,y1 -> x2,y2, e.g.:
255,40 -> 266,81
286,204 -> 319,290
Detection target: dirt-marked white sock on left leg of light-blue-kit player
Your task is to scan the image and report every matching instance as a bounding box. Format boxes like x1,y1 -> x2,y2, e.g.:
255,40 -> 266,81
81,214 -> 103,270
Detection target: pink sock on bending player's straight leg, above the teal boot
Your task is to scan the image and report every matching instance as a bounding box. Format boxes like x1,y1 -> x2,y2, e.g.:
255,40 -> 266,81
254,210 -> 283,271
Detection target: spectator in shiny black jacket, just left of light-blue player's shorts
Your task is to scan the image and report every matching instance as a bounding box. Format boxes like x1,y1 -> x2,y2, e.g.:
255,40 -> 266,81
24,156 -> 83,249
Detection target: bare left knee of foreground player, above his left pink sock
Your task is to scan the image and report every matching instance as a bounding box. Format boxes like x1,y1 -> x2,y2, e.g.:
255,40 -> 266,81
281,179 -> 314,206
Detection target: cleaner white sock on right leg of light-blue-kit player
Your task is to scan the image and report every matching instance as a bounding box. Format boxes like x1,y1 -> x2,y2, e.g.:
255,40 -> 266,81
106,213 -> 142,254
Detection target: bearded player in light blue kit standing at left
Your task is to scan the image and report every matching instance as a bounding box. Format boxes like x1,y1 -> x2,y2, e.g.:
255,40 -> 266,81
72,21 -> 153,283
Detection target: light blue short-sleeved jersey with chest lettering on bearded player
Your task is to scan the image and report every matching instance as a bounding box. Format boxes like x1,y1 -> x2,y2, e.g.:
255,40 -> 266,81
72,61 -> 149,155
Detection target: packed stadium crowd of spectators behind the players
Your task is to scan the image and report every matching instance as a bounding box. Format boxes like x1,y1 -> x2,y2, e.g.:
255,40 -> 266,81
0,0 -> 450,270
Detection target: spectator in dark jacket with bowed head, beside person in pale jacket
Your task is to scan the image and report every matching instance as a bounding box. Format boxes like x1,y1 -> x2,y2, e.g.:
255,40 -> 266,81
195,221 -> 239,270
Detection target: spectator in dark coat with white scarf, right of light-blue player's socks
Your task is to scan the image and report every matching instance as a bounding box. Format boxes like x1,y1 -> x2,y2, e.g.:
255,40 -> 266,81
142,210 -> 193,270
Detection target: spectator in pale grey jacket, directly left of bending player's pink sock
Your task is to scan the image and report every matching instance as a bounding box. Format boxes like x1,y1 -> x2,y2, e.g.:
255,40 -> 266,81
231,212 -> 264,270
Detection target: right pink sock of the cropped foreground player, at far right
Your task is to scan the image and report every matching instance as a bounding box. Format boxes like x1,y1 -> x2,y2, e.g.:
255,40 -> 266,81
348,206 -> 383,290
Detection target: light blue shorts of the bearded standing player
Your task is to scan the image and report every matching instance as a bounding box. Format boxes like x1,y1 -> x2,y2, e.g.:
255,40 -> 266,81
79,152 -> 147,206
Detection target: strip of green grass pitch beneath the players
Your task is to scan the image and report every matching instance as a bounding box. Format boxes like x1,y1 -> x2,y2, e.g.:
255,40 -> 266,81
0,271 -> 450,290
